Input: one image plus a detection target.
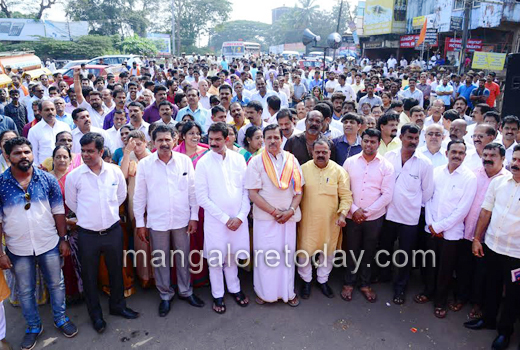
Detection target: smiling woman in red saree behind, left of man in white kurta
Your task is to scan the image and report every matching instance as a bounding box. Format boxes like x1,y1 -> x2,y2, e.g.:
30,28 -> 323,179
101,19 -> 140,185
172,121 -> 209,287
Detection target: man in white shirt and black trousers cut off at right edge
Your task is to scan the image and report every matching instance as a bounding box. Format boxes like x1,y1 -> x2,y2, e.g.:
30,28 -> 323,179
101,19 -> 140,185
464,145 -> 520,349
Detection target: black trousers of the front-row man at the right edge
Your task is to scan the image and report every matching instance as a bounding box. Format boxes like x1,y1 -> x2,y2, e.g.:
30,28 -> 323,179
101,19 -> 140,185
483,244 -> 520,336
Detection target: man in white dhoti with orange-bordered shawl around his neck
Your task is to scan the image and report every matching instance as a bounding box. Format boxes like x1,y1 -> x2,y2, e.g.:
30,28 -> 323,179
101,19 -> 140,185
245,124 -> 304,306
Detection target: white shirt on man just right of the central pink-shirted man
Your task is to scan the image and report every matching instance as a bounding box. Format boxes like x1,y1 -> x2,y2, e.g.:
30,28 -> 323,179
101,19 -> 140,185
385,148 -> 434,225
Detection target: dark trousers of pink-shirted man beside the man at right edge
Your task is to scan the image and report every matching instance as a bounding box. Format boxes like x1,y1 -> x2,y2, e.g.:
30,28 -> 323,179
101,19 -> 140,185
457,239 -> 486,306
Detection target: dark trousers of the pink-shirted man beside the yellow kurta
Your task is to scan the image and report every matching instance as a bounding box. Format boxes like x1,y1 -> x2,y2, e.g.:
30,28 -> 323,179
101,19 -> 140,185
344,216 -> 384,287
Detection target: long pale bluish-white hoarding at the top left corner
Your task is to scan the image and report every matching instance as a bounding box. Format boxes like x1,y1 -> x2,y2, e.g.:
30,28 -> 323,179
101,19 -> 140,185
0,18 -> 88,41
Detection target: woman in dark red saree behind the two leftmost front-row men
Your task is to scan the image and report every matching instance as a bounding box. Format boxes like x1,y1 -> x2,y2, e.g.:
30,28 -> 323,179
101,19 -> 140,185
50,145 -> 83,303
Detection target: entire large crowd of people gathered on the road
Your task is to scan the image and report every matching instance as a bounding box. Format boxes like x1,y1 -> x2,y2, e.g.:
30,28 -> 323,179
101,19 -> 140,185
0,52 -> 520,349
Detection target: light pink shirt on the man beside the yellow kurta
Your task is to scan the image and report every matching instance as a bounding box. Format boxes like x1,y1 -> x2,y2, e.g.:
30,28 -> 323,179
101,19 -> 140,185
343,152 -> 395,221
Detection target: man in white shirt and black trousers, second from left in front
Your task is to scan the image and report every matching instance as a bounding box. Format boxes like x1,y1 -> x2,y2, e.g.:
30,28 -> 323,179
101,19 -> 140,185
65,133 -> 139,333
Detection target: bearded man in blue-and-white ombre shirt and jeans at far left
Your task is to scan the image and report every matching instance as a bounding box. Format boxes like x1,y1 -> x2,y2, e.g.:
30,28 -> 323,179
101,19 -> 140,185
0,137 -> 78,349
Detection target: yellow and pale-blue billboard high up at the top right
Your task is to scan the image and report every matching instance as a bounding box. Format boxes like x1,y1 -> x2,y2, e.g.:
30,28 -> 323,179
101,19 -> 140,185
363,0 -> 394,35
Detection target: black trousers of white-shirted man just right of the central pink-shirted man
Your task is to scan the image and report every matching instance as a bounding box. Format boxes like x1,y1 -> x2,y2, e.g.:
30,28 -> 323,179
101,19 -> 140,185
379,220 -> 418,294
